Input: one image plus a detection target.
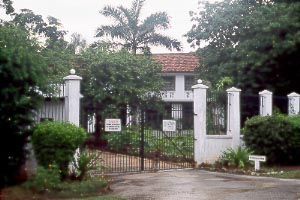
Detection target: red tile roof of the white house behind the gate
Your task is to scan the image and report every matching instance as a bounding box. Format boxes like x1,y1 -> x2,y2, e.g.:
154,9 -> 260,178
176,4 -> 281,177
152,53 -> 199,72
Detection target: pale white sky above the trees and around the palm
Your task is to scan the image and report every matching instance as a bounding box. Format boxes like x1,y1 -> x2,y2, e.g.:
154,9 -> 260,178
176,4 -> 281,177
4,0 -> 202,53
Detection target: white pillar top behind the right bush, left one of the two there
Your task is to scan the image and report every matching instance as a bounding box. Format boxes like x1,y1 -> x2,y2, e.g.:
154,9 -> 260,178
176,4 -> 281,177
259,90 -> 273,116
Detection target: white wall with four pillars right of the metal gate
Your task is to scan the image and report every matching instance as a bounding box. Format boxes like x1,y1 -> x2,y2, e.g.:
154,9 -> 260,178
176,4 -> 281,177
192,80 -> 300,164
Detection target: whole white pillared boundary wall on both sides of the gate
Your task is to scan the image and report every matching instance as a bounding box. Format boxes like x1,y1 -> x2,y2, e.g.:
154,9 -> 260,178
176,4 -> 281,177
38,70 -> 300,164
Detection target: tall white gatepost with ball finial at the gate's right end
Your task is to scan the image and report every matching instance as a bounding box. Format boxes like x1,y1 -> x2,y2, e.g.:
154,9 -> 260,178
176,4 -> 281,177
192,79 -> 208,166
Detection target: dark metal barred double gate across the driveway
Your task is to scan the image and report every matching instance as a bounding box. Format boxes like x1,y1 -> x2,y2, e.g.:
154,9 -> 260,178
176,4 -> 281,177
81,103 -> 194,174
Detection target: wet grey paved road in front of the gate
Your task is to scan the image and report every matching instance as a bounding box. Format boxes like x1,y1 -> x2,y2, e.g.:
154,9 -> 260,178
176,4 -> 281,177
111,169 -> 300,200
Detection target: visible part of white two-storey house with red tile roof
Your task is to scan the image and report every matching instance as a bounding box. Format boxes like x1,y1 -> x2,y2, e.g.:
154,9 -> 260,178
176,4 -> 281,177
147,53 -> 199,129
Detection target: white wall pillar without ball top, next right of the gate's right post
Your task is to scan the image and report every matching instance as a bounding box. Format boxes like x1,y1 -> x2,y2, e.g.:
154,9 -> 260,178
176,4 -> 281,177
226,87 -> 241,149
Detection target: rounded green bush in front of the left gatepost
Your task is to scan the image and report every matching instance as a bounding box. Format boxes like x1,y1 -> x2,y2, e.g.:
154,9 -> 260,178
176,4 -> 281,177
31,121 -> 86,178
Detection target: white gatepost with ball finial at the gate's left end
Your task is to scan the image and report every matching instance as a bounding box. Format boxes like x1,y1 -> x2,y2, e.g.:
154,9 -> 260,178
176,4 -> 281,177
64,69 -> 82,126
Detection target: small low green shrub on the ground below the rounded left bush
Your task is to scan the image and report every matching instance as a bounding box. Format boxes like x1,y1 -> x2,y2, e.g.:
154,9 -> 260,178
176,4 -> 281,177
24,165 -> 61,192
